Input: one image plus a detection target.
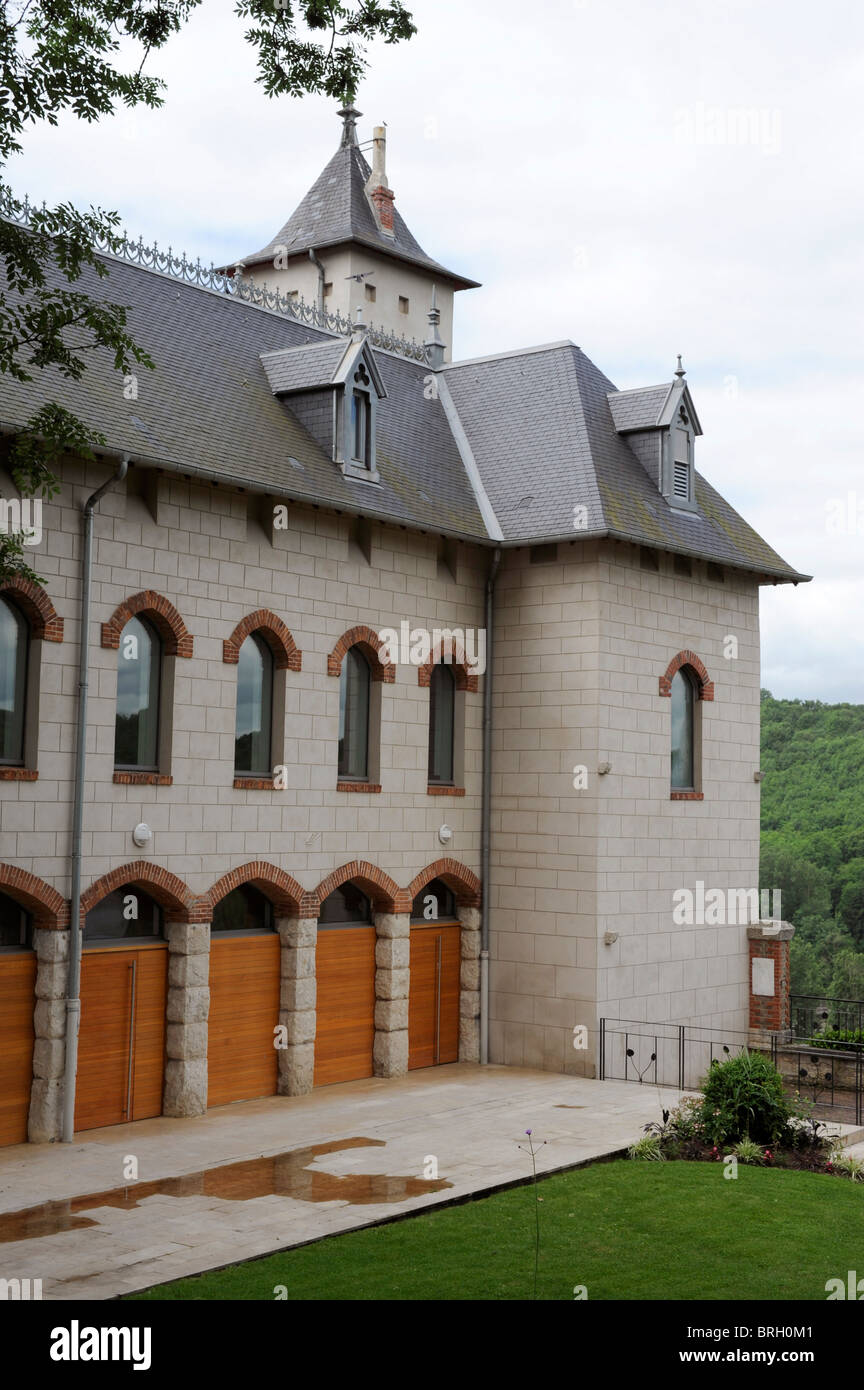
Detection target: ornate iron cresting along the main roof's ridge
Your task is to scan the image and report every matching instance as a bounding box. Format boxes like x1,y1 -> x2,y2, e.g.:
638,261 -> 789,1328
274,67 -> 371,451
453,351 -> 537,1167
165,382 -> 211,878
0,186 -> 428,364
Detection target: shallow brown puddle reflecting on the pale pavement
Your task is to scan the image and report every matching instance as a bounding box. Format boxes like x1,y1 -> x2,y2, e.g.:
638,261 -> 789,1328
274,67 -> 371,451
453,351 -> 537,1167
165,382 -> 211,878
0,1138 -> 453,1244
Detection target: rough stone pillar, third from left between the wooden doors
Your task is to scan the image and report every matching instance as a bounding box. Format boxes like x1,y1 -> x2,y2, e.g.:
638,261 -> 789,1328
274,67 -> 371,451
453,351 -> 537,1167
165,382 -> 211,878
276,917 -> 318,1095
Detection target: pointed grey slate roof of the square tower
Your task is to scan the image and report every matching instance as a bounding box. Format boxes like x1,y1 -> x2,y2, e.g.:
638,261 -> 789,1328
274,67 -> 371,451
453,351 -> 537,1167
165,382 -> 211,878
242,145 -> 478,289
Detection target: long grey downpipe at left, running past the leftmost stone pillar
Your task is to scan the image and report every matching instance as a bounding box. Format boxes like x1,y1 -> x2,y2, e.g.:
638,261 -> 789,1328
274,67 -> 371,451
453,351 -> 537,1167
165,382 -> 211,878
63,455 -> 129,1144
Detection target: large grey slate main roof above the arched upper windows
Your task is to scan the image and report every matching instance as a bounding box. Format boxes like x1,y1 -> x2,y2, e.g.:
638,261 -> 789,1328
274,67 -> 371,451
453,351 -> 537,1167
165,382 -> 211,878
0,244 -> 807,581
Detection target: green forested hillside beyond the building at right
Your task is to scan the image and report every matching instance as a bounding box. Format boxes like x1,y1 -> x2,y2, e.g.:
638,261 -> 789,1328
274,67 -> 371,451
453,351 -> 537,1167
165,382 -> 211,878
760,691 -> 864,999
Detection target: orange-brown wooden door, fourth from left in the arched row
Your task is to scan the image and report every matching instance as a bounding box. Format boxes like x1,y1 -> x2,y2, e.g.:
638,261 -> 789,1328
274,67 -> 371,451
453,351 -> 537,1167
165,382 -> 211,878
315,927 -> 375,1086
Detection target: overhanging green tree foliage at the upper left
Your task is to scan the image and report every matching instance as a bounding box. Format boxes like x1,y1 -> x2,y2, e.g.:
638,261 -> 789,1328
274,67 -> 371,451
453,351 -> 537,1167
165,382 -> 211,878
0,0 -> 417,580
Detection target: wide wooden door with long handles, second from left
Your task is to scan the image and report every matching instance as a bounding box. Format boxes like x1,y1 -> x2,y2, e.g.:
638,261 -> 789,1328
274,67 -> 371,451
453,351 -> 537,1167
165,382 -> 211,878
75,944 -> 168,1130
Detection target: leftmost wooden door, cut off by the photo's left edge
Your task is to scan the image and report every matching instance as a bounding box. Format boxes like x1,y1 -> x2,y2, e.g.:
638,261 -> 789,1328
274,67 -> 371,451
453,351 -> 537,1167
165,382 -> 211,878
0,951 -> 36,1145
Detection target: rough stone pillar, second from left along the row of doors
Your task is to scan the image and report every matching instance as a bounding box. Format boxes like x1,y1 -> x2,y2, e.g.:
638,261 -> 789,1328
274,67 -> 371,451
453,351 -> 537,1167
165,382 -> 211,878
163,922 -> 210,1116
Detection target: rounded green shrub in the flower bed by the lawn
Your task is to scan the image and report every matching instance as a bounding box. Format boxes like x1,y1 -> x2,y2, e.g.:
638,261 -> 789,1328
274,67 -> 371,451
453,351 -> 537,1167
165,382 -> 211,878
700,1052 -> 793,1148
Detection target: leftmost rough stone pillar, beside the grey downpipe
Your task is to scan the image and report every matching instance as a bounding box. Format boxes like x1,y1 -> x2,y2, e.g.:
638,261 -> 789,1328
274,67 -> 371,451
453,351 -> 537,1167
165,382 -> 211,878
28,927 -> 69,1144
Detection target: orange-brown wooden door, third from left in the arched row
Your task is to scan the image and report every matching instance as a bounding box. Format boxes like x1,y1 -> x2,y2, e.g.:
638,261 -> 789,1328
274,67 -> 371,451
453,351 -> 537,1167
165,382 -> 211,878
207,931 -> 279,1105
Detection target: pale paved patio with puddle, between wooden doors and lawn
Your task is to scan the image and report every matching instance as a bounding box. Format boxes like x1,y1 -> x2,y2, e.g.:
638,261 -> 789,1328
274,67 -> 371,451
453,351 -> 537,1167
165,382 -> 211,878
0,1065 -> 669,1300
